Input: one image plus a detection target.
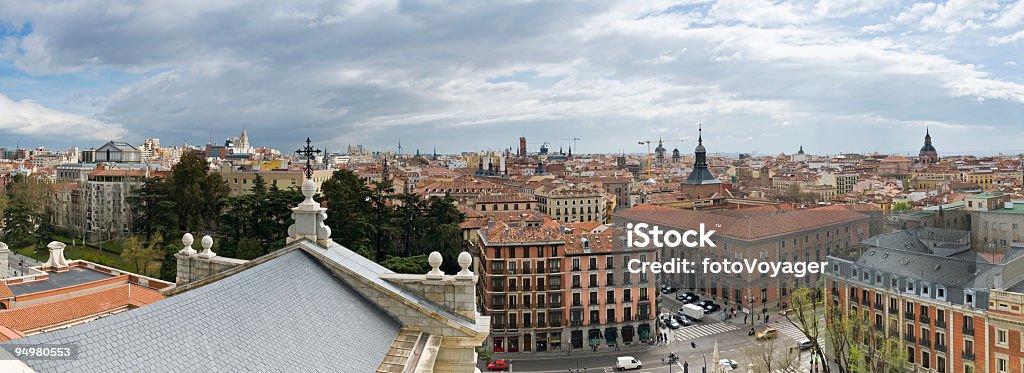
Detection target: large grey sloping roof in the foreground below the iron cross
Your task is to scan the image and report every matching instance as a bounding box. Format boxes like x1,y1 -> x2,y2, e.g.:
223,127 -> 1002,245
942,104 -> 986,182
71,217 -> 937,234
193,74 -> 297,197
2,250 -> 400,372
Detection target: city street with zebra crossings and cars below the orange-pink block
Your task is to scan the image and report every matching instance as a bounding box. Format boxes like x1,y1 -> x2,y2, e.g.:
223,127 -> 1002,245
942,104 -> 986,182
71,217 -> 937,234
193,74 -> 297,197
480,294 -> 831,373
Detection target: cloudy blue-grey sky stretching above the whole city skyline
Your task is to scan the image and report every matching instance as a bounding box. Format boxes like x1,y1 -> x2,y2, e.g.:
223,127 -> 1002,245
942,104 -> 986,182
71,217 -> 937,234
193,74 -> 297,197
0,0 -> 1024,154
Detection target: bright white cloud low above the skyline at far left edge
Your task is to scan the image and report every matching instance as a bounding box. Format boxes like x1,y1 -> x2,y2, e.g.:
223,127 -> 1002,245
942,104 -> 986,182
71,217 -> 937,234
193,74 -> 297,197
0,93 -> 125,140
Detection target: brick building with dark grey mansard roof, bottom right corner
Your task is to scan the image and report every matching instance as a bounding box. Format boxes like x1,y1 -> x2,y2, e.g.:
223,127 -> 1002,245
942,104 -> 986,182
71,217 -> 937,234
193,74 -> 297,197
826,227 -> 1024,373
